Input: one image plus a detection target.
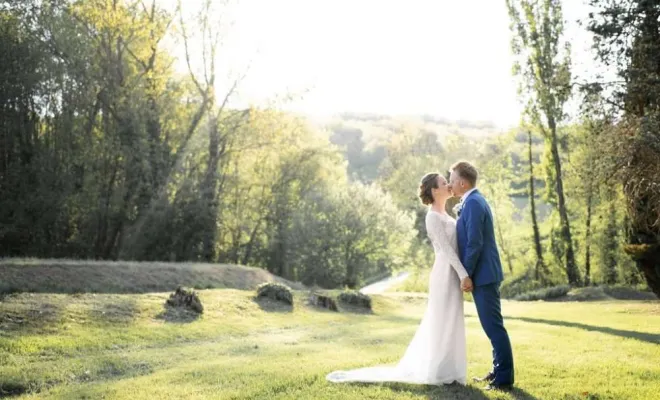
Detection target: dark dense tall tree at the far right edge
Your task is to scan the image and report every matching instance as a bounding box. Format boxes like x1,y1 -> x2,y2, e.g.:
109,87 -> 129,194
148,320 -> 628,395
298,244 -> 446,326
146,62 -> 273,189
589,0 -> 660,297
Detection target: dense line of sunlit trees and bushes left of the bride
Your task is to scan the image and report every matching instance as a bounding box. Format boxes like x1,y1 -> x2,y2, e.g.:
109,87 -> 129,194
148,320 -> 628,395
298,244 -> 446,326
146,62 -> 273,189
0,0 -> 414,287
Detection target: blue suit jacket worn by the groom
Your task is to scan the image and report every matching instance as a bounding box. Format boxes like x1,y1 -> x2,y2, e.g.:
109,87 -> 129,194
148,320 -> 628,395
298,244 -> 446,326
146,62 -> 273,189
456,190 -> 504,286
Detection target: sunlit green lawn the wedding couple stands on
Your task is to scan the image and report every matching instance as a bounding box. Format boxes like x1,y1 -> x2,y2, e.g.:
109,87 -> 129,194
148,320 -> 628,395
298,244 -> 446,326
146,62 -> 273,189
0,289 -> 660,400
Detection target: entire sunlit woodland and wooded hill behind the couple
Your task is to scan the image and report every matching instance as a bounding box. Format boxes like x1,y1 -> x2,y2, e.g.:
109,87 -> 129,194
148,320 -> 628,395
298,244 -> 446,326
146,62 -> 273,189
0,0 -> 660,294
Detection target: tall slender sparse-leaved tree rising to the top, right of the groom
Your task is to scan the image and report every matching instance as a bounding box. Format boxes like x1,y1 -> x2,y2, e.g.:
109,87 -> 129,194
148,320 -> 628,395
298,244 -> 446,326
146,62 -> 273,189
507,0 -> 581,285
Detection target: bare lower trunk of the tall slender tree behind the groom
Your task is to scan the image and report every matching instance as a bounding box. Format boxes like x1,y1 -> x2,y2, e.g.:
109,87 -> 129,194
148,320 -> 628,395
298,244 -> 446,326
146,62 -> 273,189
548,117 -> 580,286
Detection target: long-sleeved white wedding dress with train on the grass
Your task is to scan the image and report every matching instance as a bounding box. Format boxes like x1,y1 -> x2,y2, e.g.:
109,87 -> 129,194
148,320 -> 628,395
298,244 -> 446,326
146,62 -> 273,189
326,211 -> 468,385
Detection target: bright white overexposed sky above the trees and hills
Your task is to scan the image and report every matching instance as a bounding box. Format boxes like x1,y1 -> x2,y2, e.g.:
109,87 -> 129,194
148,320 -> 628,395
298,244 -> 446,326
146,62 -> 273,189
161,0 -> 592,127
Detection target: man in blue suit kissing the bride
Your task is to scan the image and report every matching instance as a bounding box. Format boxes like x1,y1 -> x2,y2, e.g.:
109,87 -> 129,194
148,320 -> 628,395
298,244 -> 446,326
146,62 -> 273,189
449,161 -> 514,390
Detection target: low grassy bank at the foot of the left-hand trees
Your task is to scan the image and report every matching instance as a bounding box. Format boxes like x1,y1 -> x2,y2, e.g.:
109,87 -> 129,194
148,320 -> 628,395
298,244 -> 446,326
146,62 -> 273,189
0,259 -> 304,294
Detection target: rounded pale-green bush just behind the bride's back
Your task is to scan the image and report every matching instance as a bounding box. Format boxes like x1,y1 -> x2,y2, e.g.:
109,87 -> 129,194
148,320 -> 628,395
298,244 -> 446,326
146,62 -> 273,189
288,183 -> 415,288
